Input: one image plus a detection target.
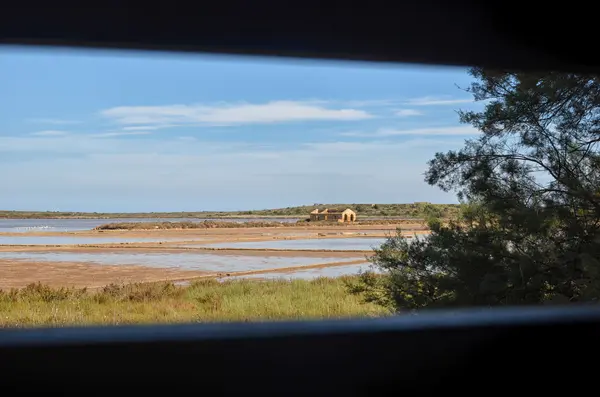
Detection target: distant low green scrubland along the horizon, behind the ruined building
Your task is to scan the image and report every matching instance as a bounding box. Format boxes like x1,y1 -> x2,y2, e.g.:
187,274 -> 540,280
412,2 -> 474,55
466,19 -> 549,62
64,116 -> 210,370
0,203 -> 459,219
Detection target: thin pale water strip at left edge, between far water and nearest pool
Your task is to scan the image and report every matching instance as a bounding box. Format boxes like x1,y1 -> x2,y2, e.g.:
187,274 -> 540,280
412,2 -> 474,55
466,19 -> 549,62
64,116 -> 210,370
0,235 -> 183,245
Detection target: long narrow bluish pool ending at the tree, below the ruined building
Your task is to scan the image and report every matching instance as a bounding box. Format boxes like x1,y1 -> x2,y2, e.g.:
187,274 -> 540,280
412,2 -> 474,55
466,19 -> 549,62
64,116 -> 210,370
195,237 -> 385,251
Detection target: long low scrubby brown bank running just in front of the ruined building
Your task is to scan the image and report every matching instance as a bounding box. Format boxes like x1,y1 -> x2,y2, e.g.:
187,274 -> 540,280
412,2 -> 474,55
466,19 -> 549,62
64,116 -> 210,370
94,219 -> 425,230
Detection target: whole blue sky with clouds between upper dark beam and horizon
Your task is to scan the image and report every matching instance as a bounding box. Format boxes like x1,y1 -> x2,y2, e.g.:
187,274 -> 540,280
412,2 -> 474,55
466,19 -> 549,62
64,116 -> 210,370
0,47 -> 481,211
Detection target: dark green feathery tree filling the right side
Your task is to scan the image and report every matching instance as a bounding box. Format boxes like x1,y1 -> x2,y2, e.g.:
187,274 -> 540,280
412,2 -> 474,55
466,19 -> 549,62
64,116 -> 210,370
356,68 -> 600,308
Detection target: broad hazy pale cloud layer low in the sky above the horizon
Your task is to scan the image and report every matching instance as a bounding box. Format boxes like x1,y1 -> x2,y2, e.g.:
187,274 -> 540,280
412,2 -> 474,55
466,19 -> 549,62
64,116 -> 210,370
0,134 -> 462,211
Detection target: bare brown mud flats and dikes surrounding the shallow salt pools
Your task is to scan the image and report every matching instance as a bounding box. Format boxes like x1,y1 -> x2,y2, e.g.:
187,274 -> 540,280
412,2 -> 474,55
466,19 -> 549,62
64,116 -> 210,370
0,224 -> 428,289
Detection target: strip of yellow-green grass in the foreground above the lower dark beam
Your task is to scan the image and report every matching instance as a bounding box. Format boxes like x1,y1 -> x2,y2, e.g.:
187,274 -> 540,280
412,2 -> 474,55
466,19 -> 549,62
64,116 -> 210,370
0,277 -> 388,327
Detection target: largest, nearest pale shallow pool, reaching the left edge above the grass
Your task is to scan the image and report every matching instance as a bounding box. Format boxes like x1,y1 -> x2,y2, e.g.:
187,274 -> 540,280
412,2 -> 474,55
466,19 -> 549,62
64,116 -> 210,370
0,252 -> 360,272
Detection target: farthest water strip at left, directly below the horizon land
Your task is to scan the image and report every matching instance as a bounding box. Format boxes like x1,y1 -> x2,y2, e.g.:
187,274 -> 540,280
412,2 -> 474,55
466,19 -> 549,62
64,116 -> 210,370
0,218 -> 298,233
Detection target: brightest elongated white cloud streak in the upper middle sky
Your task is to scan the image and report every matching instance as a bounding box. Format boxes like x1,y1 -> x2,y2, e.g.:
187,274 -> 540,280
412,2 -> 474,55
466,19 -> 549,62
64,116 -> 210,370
101,101 -> 373,125
